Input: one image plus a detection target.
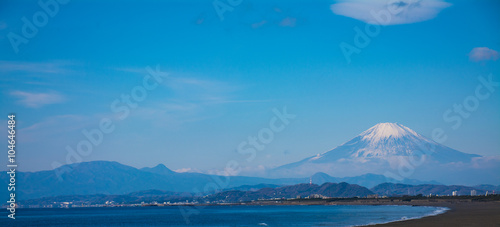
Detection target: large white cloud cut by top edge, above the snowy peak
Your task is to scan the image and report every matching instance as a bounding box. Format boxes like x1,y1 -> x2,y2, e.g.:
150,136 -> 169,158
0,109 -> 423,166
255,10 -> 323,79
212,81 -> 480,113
330,0 -> 451,25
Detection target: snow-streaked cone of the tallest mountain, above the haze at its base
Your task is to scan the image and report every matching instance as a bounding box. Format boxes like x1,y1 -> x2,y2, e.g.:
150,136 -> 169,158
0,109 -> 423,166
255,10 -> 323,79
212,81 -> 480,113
278,123 -> 480,169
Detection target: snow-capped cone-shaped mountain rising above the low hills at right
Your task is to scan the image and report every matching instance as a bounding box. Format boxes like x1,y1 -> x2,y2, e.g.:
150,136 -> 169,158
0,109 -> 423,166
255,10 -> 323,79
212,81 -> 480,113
273,123 -> 480,176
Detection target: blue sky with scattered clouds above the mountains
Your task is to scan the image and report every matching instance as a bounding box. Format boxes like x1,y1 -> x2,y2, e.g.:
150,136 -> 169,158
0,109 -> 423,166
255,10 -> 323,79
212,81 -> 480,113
0,0 -> 500,175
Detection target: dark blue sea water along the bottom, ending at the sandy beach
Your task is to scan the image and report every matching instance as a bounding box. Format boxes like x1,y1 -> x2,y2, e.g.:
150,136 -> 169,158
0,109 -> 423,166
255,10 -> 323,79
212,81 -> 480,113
0,205 -> 446,226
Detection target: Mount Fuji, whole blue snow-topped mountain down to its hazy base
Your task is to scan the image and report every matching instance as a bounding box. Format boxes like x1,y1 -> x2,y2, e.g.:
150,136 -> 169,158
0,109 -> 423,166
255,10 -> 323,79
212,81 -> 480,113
269,123 -> 494,184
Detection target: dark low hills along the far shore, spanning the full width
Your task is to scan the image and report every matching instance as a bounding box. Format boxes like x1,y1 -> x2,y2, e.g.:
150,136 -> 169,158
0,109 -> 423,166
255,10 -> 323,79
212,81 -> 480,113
19,182 -> 500,206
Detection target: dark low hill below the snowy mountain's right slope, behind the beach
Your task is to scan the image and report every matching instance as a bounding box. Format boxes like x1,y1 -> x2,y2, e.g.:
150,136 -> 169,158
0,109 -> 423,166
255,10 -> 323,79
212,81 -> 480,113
371,183 -> 486,196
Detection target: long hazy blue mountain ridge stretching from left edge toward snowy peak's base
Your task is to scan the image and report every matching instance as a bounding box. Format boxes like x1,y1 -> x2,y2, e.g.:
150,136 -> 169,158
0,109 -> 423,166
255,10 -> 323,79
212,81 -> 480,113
0,161 -> 438,201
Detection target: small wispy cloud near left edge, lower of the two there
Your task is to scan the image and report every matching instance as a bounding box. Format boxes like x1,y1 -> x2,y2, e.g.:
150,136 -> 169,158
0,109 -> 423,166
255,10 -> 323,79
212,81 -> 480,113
10,91 -> 66,108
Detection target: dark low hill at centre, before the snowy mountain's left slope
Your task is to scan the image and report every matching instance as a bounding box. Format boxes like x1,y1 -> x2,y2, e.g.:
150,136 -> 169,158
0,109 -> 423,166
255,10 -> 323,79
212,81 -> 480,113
206,182 -> 374,202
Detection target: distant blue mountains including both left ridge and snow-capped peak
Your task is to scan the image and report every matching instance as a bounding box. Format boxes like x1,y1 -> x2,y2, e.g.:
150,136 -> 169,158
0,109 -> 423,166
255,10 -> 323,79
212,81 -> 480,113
0,123 -> 500,200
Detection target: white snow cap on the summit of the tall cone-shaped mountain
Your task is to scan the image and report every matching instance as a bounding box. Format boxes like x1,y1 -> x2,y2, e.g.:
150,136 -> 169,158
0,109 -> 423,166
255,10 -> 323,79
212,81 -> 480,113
360,123 -> 420,142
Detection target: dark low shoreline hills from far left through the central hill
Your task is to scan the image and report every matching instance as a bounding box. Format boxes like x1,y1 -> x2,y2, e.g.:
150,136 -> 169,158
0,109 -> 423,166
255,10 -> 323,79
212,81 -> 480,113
19,182 -> 373,206
